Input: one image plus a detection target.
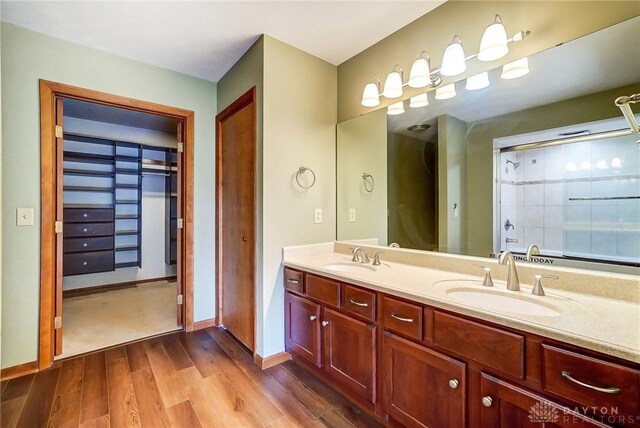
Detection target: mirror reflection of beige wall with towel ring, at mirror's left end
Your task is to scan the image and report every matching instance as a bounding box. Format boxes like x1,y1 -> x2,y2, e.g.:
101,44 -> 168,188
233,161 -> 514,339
336,109 -> 387,245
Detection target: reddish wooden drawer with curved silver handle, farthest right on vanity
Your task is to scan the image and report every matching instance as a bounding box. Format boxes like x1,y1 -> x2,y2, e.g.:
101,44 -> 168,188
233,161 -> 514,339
542,344 -> 640,415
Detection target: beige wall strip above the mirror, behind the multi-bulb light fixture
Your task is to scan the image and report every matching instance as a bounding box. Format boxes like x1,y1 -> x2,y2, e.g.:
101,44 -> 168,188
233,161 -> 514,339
338,1 -> 640,122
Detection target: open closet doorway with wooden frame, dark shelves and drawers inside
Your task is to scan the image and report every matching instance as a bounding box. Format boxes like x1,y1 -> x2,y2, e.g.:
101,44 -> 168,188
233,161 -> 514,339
39,81 -> 193,368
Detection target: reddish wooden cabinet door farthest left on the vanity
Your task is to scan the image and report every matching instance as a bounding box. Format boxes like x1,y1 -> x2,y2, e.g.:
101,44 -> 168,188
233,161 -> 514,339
285,293 -> 322,367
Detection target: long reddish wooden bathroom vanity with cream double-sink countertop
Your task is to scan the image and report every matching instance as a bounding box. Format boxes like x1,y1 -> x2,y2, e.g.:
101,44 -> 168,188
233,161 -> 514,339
283,243 -> 640,427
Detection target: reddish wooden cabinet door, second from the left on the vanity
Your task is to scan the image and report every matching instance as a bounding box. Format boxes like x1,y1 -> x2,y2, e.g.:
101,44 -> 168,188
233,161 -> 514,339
322,308 -> 376,403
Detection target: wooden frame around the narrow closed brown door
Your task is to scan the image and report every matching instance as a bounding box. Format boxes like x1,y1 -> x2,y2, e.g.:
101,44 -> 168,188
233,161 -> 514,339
215,86 -> 258,358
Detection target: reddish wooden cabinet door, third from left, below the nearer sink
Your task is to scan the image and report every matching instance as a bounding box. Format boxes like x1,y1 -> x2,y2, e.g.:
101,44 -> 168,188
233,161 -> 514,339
381,333 -> 466,428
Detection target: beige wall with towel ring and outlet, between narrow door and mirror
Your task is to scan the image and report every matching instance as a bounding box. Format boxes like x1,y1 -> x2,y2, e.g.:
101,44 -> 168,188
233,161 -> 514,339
258,36 -> 337,356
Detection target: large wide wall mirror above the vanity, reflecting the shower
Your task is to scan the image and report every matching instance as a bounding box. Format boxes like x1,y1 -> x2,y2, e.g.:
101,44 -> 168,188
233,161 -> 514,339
337,17 -> 640,273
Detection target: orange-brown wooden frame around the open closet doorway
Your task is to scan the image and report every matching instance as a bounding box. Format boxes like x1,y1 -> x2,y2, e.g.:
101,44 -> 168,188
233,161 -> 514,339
38,80 -> 194,370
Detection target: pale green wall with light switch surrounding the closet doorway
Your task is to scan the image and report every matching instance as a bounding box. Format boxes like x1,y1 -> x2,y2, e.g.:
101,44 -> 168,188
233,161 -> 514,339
1,23 -> 216,367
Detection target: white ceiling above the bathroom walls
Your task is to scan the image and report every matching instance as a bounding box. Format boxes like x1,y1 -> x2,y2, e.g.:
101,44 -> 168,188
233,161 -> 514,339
1,0 -> 445,82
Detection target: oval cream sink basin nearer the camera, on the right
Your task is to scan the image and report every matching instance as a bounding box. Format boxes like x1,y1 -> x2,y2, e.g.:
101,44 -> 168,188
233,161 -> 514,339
446,287 -> 562,317
